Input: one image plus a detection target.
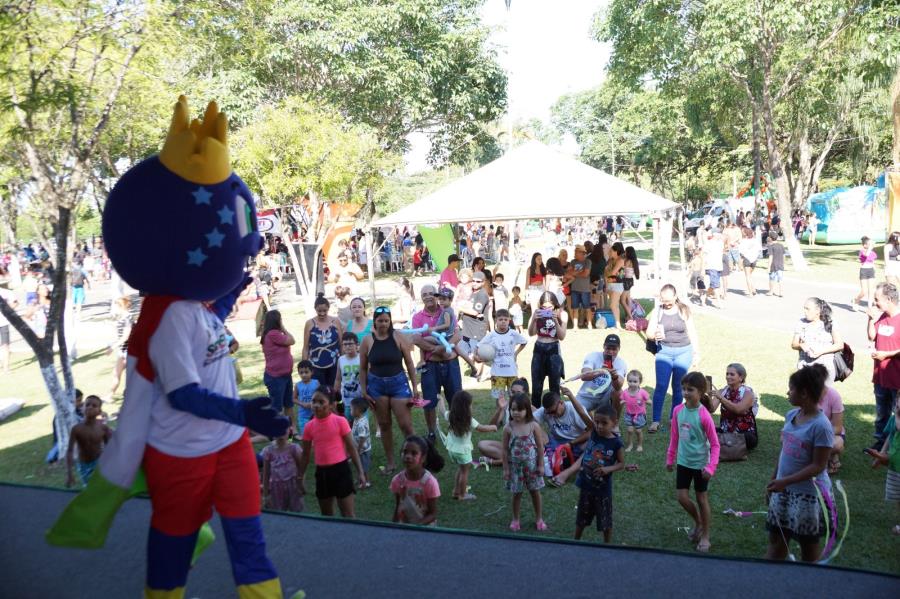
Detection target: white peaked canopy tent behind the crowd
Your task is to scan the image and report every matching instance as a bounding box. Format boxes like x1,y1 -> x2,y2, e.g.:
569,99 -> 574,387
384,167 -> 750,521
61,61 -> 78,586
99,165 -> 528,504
366,141 -> 683,298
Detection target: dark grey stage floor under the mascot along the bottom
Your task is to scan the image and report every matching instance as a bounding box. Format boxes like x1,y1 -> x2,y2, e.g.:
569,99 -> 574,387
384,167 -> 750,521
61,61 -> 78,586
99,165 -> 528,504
0,484 -> 900,599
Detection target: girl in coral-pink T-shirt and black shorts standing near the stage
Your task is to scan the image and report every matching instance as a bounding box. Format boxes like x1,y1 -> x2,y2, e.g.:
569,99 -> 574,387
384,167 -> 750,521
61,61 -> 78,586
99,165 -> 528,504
299,387 -> 366,518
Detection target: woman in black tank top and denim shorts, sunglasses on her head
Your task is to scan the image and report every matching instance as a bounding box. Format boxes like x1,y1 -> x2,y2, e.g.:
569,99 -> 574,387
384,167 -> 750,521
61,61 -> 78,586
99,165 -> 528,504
359,306 -> 419,474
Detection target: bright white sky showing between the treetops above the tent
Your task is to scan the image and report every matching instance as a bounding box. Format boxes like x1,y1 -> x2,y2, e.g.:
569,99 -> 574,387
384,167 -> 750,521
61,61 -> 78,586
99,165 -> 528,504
406,0 -> 609,173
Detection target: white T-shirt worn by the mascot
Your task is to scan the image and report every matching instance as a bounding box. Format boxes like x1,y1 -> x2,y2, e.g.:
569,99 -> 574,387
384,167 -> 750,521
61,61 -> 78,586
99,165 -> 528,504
145,300 -> 244,457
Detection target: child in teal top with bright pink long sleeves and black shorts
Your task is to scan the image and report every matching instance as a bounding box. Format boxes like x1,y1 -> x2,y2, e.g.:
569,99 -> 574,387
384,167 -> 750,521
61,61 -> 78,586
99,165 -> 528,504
666,372 -> 719,553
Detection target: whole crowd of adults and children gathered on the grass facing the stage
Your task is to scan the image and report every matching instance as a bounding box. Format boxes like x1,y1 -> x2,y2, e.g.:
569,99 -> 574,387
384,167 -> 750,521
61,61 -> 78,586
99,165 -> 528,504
7,220 -> 900,561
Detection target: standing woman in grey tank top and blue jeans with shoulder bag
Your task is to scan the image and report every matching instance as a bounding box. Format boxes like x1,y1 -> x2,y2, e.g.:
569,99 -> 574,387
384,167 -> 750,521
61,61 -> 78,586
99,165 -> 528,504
647,284 -> 700,433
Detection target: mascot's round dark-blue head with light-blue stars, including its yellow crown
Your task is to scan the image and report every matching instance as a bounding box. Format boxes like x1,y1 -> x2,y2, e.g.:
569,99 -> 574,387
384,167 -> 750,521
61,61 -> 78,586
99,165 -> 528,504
103,96 -> 262,301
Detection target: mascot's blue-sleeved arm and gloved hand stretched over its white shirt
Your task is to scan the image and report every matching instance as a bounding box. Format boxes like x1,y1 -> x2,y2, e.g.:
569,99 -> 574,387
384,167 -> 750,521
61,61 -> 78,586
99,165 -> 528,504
169,383 -> 290,437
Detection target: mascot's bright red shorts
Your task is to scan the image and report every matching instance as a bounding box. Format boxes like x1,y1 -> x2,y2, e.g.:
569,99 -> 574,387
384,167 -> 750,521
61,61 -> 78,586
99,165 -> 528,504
144,431 -> 260,537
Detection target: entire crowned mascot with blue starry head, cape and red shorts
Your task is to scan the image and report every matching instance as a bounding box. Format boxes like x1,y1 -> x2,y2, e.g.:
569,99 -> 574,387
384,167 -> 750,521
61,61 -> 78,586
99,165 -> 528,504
47,96 -> 288,599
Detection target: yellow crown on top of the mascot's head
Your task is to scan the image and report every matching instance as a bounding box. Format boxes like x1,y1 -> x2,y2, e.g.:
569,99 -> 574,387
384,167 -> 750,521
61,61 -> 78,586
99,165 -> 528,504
159,96 -> 231,185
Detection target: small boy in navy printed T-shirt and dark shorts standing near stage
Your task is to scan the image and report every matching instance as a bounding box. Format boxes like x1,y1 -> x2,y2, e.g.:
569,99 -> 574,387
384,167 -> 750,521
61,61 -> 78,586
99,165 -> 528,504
575,404 -> 625,543
